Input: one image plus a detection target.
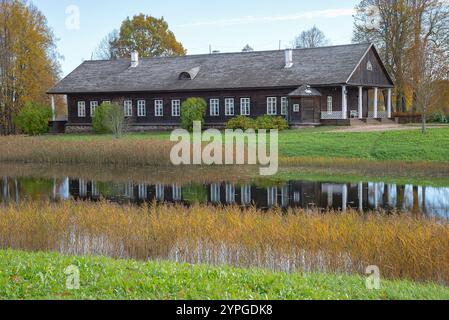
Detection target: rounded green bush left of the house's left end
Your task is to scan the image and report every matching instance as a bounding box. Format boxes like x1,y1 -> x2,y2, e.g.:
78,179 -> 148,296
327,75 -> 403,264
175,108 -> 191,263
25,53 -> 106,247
14,103 -> 52,136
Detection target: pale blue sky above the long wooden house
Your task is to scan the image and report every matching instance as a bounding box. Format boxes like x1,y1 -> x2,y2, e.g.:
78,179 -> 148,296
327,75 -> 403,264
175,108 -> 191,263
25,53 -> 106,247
32,0 -> 359,76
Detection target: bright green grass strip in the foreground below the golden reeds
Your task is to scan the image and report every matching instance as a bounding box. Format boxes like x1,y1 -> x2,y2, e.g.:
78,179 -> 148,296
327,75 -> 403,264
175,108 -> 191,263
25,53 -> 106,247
0,250 -> 449,300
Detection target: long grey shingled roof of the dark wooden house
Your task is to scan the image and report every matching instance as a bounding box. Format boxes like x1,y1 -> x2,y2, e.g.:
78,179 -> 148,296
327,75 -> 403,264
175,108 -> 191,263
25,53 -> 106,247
48,44 -> 371,94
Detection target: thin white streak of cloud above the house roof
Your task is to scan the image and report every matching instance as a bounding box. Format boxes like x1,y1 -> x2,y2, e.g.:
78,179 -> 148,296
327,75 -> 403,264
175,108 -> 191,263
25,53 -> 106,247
177,9 -> 355,27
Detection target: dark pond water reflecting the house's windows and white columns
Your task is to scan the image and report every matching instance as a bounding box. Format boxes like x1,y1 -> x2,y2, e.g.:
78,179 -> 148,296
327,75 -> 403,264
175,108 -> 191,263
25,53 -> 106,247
0,177 -> 449,218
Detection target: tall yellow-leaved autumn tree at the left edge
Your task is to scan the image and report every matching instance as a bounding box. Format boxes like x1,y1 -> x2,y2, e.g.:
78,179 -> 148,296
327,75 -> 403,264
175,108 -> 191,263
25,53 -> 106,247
0,0 -> 59,134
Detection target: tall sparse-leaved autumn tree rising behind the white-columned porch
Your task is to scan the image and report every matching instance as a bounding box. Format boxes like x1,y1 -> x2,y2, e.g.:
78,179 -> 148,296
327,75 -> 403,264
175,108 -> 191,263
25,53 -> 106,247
353,0 -> 449,112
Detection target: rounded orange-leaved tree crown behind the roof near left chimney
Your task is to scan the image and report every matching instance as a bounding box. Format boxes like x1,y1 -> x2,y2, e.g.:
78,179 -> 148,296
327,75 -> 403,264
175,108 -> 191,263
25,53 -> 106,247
106,14 -> 186,58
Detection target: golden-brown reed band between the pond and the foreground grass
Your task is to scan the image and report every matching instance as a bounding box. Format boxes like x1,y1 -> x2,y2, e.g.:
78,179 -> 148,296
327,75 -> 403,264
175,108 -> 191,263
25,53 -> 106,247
0,201 -> 449,285
